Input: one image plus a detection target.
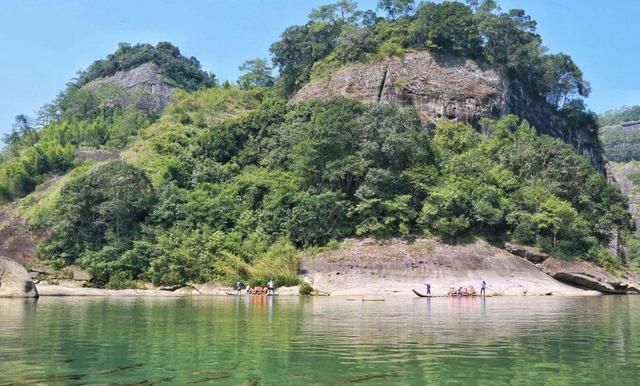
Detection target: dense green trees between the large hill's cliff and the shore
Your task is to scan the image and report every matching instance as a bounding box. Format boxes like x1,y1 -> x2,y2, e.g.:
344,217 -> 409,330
27,88 -> 628,286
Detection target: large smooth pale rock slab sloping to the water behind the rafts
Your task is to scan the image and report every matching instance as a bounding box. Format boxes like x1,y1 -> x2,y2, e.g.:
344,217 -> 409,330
302,238 -> 595,296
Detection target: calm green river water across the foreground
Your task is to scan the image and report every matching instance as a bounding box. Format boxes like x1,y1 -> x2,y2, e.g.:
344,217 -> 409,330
0,294 -> 640,386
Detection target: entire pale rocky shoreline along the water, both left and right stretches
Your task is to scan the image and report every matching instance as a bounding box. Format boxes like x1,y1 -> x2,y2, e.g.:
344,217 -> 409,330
0,238 -> 640,297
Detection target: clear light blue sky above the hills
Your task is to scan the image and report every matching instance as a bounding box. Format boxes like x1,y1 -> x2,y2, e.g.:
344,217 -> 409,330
0,0 -> 640,134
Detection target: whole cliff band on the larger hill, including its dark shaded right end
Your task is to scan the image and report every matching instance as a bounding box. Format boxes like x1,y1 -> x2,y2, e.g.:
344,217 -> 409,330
292,52 -> 604,170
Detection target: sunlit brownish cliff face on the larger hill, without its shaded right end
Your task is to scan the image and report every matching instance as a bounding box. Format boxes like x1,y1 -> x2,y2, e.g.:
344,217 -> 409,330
293,52 -> 507,123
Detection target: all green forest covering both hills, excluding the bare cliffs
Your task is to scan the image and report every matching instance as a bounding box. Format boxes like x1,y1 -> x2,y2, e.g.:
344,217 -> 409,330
0,0 -> 629,288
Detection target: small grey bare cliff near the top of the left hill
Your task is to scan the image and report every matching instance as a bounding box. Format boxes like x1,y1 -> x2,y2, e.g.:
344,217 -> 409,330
82,63 -> 176,111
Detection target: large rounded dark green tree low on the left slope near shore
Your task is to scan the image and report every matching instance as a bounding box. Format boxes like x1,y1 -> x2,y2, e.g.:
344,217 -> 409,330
39,161 -> 154,272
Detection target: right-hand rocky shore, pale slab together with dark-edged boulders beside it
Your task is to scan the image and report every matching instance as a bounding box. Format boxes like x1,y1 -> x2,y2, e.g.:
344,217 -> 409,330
302,238 -> 640,296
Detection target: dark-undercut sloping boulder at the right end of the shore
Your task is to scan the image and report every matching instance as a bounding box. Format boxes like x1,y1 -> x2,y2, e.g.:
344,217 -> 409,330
541,258 -> 640,294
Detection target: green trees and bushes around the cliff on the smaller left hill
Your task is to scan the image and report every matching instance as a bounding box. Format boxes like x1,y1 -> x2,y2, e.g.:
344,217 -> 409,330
0,42 -> 216,202
